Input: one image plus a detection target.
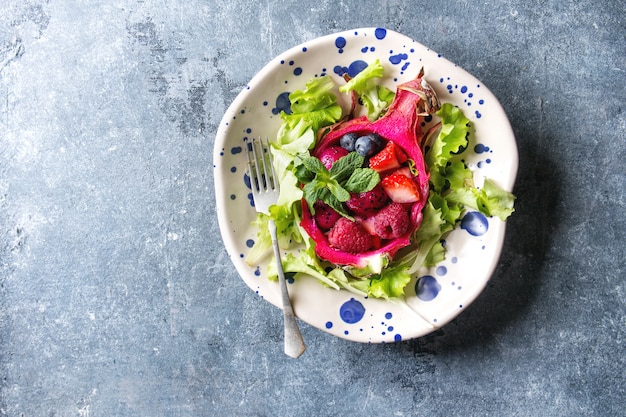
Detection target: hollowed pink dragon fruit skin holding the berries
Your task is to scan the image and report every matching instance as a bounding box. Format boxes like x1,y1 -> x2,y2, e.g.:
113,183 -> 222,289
301,71 -> 439,273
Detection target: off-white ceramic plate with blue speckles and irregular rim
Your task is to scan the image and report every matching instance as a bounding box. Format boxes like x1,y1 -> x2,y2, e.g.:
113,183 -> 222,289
214,28 -> 518,343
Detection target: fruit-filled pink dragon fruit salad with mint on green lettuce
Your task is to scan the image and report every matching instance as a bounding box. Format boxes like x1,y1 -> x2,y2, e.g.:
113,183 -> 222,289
246,61 -> 514,298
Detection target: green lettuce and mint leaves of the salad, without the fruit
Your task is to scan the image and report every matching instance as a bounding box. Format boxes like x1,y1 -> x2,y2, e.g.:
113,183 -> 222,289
245,60 -> 515,299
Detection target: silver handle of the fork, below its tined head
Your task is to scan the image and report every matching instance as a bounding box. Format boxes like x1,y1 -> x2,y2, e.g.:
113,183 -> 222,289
268,219 -> 306,358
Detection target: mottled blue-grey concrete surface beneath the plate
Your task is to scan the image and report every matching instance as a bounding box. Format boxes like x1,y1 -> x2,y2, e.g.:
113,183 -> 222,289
0,0 -> 626,417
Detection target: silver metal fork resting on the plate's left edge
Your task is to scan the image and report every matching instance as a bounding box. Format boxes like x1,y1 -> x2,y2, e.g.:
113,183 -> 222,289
246,138 -> 306,358
